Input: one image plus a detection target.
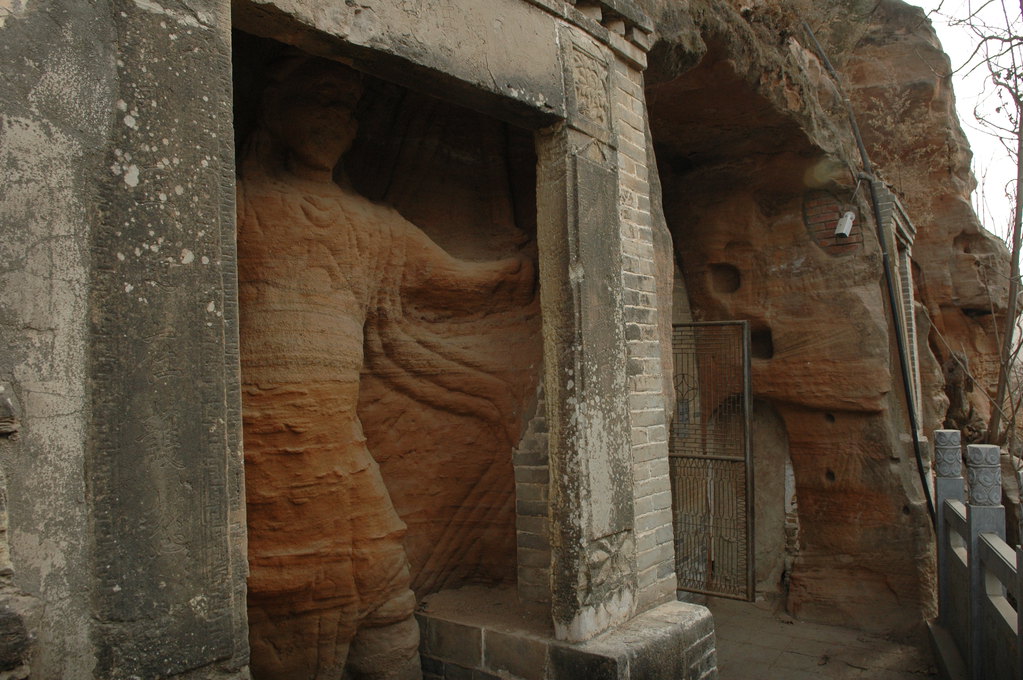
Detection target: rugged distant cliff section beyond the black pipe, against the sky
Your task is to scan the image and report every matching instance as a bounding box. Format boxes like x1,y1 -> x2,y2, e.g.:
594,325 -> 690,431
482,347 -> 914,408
842,2 -> 1009,441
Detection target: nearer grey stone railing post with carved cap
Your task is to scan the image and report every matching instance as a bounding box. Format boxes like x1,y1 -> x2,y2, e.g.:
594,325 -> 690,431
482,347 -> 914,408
966,444 -> 1006,680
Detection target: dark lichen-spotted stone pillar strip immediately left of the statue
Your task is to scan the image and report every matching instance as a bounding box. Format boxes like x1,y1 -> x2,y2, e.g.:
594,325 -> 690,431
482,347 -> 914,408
82,0 -> 248,678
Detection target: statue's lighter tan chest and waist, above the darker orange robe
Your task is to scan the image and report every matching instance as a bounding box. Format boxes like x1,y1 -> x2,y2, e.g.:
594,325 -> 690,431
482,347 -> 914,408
238,174 -> 393,390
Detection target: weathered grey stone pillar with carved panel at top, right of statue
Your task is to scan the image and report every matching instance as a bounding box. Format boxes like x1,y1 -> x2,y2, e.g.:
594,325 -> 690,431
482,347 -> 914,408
537,31 -> 636,641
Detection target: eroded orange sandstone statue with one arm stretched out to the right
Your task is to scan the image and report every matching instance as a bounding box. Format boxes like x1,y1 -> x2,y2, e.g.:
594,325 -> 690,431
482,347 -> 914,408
238,57 -> 535,680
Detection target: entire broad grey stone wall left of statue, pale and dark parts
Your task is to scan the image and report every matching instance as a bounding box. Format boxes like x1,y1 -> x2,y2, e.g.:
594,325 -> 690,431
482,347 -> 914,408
0,0 -> 248,680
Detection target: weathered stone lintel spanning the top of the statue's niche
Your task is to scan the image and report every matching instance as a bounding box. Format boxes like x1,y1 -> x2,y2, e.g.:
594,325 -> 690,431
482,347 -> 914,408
233,0 -> 565,127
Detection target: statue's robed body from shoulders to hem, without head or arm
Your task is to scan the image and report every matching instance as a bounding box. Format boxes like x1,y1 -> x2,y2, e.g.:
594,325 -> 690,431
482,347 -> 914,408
238,177 -> 407,605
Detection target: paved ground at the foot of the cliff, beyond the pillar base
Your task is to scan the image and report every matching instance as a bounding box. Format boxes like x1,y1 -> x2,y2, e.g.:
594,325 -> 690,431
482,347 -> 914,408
707,599 -> 937,680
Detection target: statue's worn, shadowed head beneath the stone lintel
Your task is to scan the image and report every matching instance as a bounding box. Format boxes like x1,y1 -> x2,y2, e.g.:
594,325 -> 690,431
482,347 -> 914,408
262,54 -> 362,171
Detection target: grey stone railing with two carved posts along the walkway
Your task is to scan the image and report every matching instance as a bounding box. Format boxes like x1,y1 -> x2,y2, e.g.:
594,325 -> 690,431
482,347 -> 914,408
931,429 -> 1023,680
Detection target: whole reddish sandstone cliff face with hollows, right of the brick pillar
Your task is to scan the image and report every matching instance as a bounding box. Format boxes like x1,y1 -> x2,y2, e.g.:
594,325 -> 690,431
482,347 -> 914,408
641,0 -> 1008,631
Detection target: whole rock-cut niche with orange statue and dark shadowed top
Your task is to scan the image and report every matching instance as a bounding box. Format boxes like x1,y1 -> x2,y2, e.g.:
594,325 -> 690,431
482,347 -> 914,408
234,34 -> 540,680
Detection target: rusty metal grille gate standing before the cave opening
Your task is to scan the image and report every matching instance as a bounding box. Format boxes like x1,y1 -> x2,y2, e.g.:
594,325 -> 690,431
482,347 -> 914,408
668,321 -> 754,601
